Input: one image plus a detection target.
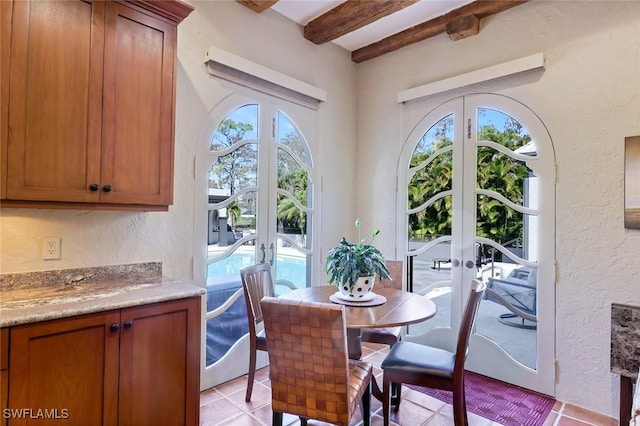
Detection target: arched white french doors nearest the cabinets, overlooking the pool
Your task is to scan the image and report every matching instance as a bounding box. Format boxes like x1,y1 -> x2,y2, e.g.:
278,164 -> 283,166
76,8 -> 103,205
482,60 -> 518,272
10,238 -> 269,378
194,92 -> 317,389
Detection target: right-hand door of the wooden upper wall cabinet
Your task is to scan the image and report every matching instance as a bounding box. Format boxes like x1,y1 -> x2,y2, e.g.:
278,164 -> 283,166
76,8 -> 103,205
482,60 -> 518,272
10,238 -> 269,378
101,3 -> 176,205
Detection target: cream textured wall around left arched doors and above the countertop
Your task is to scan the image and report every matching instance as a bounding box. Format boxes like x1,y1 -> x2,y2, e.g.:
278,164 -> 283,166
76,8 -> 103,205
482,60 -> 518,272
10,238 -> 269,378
0,1 -> 355,286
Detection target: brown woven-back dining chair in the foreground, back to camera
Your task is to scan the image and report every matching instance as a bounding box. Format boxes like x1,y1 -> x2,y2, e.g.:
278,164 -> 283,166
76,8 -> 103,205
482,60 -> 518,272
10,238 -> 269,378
262,297 -> 373,426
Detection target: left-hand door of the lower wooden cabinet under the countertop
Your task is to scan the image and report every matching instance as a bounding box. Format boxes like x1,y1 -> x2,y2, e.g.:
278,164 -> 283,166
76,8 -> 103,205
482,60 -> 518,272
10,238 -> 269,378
9,311 -> 120,426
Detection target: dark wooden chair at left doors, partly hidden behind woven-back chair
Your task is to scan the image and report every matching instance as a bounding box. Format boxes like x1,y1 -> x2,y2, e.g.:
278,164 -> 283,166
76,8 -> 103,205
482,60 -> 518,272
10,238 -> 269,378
240,263 -> 275,402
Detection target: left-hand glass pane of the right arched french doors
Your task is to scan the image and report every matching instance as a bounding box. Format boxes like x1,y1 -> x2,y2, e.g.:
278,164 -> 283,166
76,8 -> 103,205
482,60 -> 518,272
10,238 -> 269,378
407,114 -> 454,334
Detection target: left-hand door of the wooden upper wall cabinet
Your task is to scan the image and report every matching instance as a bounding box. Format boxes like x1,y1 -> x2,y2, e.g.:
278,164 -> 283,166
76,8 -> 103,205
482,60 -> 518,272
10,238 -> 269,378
3,1 -> 105,202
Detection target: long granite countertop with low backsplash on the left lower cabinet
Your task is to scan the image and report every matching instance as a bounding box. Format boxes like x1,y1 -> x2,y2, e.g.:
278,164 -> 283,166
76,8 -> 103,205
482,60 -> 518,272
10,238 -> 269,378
0,262 -> 206,327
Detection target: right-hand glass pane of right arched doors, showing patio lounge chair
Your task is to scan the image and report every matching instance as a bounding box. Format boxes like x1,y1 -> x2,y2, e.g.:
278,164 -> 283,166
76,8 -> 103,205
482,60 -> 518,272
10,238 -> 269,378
476,108 -> 538,369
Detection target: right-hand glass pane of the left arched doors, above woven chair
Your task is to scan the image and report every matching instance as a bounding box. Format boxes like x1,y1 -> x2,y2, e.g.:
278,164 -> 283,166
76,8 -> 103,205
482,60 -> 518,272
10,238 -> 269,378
275,111 -> 313,293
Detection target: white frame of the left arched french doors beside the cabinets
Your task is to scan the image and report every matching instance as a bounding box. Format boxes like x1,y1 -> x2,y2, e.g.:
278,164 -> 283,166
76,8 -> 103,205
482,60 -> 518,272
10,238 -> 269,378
193,89 -> 320,390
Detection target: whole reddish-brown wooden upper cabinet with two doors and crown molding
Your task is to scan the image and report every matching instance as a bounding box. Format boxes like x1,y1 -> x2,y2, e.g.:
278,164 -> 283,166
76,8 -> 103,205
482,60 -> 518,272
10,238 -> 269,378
1,0 -> 192,210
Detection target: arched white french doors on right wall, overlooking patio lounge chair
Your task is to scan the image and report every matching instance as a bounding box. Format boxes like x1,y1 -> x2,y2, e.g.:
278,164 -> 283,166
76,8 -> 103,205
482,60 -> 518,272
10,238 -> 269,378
398,94 -> 555,395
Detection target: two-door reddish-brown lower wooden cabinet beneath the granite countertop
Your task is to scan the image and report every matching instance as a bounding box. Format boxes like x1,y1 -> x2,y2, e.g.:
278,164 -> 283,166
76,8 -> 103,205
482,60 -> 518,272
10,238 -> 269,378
3,297 -> 200,426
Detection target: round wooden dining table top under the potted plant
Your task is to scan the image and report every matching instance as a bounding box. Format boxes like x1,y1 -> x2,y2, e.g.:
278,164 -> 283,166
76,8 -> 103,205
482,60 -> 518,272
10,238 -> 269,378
280,285 -> 437,328
